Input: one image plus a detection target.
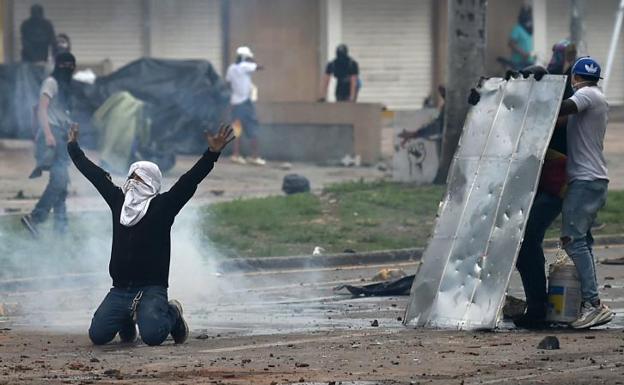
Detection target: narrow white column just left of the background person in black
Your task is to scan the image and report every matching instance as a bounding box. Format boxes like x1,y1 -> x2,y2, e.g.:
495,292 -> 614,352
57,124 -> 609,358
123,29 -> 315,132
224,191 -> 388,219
319,0 -> 343,101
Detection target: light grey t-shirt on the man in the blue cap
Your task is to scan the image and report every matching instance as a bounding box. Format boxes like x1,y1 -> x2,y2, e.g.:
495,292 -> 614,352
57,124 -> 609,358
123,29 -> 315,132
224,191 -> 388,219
567,86 -> 609,182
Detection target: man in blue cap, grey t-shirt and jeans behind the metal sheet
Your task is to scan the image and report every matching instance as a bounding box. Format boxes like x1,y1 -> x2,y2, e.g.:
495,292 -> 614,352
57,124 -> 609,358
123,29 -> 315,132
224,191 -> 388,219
559,57 -> 614,329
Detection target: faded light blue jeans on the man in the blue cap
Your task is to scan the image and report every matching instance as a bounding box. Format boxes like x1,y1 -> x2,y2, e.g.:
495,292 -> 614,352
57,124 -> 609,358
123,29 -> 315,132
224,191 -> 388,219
561,179 -> 609,304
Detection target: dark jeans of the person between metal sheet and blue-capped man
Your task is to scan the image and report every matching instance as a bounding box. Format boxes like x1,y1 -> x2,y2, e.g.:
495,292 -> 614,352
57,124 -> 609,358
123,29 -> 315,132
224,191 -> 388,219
516,191 -> 562,318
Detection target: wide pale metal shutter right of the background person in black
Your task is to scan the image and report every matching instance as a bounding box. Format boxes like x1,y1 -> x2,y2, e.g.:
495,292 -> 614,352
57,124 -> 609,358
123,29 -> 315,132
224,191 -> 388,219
342,0 -> 432,110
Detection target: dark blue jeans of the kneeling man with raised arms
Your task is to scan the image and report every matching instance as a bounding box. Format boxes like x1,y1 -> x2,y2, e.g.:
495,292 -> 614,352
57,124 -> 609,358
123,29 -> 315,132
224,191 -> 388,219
89,286 -> 178,346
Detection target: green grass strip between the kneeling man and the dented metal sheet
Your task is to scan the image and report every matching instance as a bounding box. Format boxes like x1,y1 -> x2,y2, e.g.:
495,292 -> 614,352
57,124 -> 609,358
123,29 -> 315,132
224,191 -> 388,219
202,182 -> 444,257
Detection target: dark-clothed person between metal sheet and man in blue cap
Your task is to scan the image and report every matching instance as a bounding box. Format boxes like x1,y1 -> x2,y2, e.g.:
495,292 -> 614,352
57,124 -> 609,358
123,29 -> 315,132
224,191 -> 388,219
513,40 -> 577,329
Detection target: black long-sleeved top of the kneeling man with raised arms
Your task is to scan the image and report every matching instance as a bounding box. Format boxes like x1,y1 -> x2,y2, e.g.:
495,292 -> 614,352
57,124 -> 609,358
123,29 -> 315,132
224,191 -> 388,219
67,143 -> 220,287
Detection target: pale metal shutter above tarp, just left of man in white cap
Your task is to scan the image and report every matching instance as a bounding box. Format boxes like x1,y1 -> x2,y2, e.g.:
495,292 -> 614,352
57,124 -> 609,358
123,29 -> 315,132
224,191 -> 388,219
151,0 -> 222,72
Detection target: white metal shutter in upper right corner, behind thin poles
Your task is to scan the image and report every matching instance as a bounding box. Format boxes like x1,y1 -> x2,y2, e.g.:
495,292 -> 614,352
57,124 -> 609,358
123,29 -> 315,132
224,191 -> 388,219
546,0 -> 624,104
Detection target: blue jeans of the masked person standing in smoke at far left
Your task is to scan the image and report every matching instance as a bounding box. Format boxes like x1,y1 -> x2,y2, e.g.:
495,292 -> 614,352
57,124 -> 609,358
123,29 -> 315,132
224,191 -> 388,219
30,127 -> 69,232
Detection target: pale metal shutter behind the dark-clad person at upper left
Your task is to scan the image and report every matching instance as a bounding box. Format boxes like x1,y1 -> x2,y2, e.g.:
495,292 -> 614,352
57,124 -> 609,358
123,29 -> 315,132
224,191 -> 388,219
13,0 -> 143,69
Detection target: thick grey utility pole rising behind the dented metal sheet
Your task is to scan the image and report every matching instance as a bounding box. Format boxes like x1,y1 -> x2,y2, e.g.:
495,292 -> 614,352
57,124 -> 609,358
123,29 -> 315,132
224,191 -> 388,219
435,0 -> 487,184
